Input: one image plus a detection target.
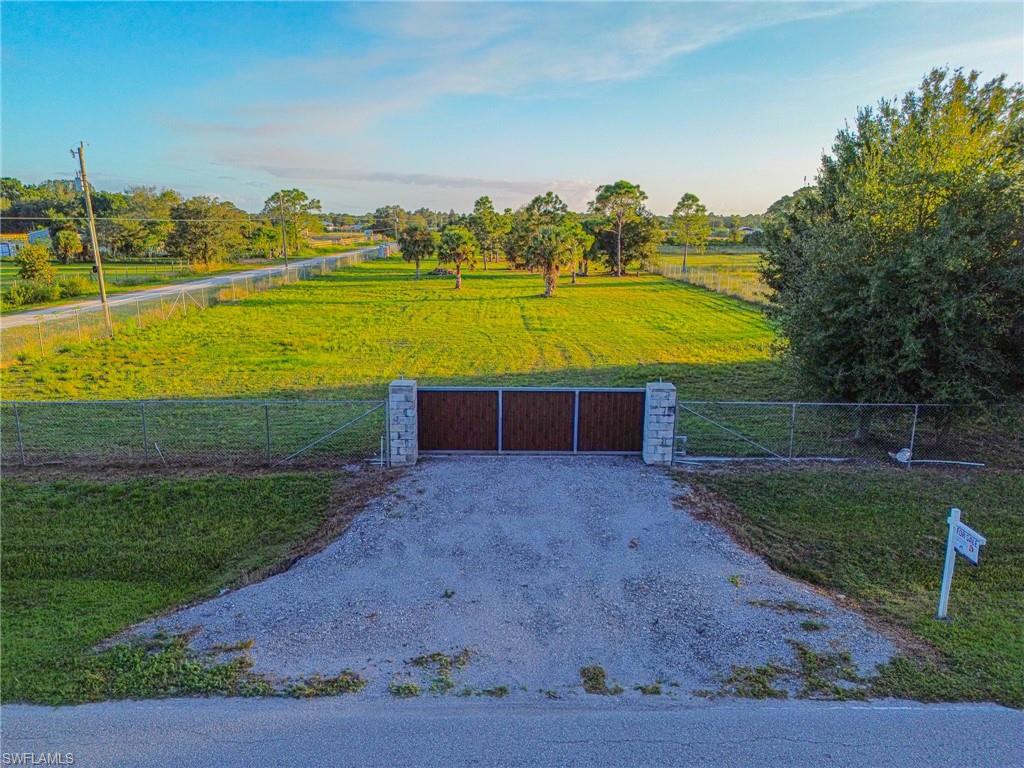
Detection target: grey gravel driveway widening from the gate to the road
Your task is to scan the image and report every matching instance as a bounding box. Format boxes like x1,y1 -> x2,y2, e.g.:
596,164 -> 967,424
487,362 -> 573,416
137,457 -> 895,696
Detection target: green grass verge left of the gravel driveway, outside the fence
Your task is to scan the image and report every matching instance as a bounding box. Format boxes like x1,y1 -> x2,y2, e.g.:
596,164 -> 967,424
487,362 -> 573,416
0,474 -> 332,703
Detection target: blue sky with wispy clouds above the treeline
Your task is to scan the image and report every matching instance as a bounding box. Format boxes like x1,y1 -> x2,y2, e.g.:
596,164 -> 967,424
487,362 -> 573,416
0,2 -> 1024,213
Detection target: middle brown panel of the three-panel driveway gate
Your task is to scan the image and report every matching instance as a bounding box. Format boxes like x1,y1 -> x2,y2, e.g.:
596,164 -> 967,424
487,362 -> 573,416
502,390 -> 575,451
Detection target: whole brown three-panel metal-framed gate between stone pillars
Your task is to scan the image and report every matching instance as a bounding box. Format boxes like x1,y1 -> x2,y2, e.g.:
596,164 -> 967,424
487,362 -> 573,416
417,387 -> 645,454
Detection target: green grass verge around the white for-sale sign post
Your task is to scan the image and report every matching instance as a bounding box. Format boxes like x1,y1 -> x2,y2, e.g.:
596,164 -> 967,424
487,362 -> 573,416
685,468 -> 1024,707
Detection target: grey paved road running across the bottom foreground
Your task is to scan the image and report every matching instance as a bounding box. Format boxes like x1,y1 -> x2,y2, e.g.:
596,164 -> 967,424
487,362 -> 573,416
0,697 -> 1024,768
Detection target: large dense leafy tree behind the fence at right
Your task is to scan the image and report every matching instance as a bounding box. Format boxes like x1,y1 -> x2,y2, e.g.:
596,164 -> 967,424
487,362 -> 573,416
764,70 -> 1024,403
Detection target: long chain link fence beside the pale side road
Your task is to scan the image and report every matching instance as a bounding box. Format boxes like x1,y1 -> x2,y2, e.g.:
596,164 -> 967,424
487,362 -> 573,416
0,245 -> 388,365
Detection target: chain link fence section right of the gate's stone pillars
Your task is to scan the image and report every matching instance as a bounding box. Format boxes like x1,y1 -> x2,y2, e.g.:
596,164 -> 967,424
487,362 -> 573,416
676,400 -> 1024,468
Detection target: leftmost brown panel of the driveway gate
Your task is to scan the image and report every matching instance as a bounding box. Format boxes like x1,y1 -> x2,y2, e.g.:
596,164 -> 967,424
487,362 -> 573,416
416,389 -> 498,451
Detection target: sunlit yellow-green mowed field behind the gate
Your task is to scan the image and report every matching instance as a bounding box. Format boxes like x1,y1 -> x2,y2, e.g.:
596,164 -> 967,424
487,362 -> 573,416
3,258 -> 796,399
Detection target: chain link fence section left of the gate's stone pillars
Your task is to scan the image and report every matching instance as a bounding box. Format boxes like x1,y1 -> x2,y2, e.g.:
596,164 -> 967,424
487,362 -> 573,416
0,400 -> 387,468
